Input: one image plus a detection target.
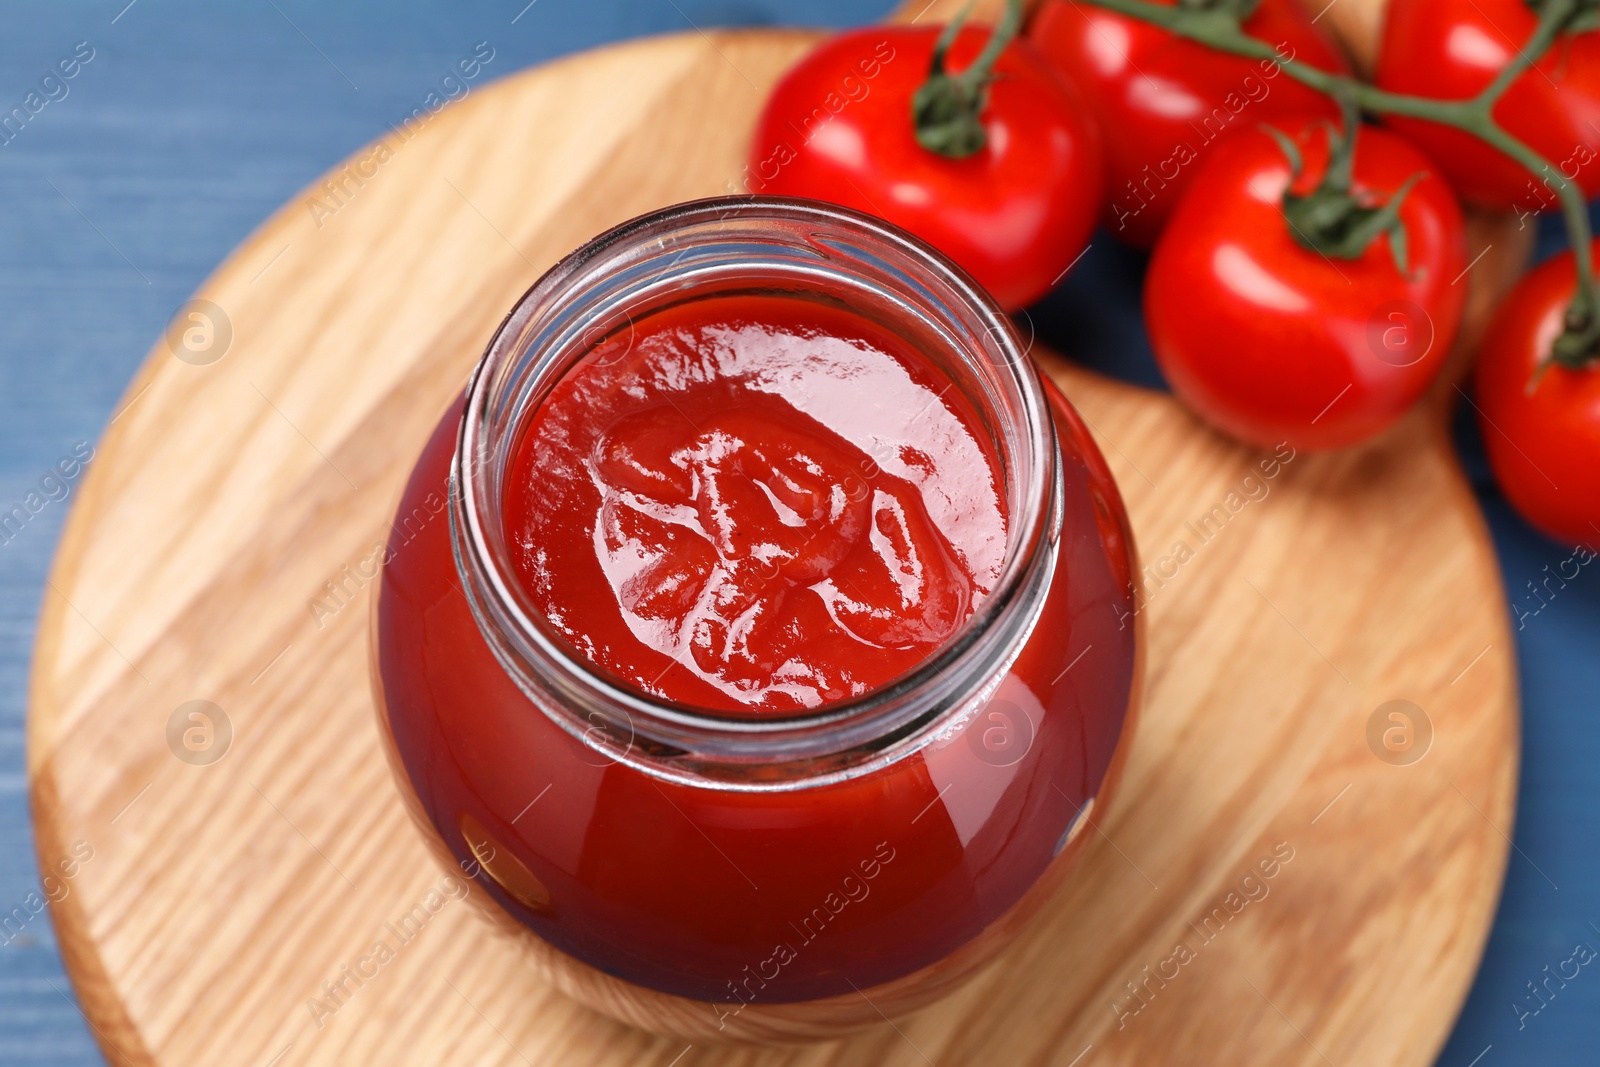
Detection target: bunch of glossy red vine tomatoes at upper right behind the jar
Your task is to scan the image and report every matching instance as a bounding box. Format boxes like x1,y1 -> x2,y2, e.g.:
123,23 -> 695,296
746,0 -> 1600,547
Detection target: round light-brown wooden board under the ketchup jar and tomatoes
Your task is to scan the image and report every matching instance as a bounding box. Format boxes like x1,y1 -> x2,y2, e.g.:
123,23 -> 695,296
29,18 -> 1518,1067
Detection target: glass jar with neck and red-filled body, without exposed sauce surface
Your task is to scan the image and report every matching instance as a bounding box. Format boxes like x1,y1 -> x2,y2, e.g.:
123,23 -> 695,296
373,198 -> 1141,1040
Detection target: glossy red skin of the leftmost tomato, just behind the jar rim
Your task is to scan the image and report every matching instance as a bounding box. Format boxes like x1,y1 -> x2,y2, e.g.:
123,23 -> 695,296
744,27 -> 1104,310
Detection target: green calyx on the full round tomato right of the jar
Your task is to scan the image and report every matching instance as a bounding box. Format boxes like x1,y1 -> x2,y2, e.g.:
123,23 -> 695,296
1262,107 -> 1426,275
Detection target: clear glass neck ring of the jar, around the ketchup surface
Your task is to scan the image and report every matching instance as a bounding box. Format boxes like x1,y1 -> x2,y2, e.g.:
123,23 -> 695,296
450,198 -> 1062,790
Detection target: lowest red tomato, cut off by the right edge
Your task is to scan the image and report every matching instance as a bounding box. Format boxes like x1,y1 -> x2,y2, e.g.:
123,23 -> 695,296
1477,242 -> 1600,552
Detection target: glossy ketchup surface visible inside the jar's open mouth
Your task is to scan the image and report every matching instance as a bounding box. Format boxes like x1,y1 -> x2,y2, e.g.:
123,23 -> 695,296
504,296 -> 1006,712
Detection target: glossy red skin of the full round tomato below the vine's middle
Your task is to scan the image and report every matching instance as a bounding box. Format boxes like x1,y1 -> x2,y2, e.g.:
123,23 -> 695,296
1144,120 -> 1466,450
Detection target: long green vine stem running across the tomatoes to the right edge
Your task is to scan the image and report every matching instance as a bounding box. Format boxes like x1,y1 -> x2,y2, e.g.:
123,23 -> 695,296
1088,0 -> 1600,366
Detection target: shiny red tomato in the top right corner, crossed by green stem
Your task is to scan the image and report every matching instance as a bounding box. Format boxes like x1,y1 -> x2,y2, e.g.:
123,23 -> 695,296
1376,0 -> 1600,213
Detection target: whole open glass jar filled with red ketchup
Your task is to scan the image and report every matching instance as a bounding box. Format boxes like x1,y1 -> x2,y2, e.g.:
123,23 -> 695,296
373,198 -> 1141,1040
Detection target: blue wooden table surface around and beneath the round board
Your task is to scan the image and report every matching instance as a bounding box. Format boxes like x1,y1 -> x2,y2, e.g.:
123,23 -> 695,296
0,0 -> 1600,1067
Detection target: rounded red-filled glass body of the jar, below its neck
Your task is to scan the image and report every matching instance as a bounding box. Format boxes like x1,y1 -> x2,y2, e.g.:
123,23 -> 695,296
374,389 -> 1138,1033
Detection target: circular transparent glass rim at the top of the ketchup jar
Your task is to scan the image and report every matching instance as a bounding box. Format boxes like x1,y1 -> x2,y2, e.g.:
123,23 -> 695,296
450,197 -> 1061,789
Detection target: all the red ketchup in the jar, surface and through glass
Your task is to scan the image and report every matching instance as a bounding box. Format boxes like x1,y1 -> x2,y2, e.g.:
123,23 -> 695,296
376,286 -> 1136,1011
